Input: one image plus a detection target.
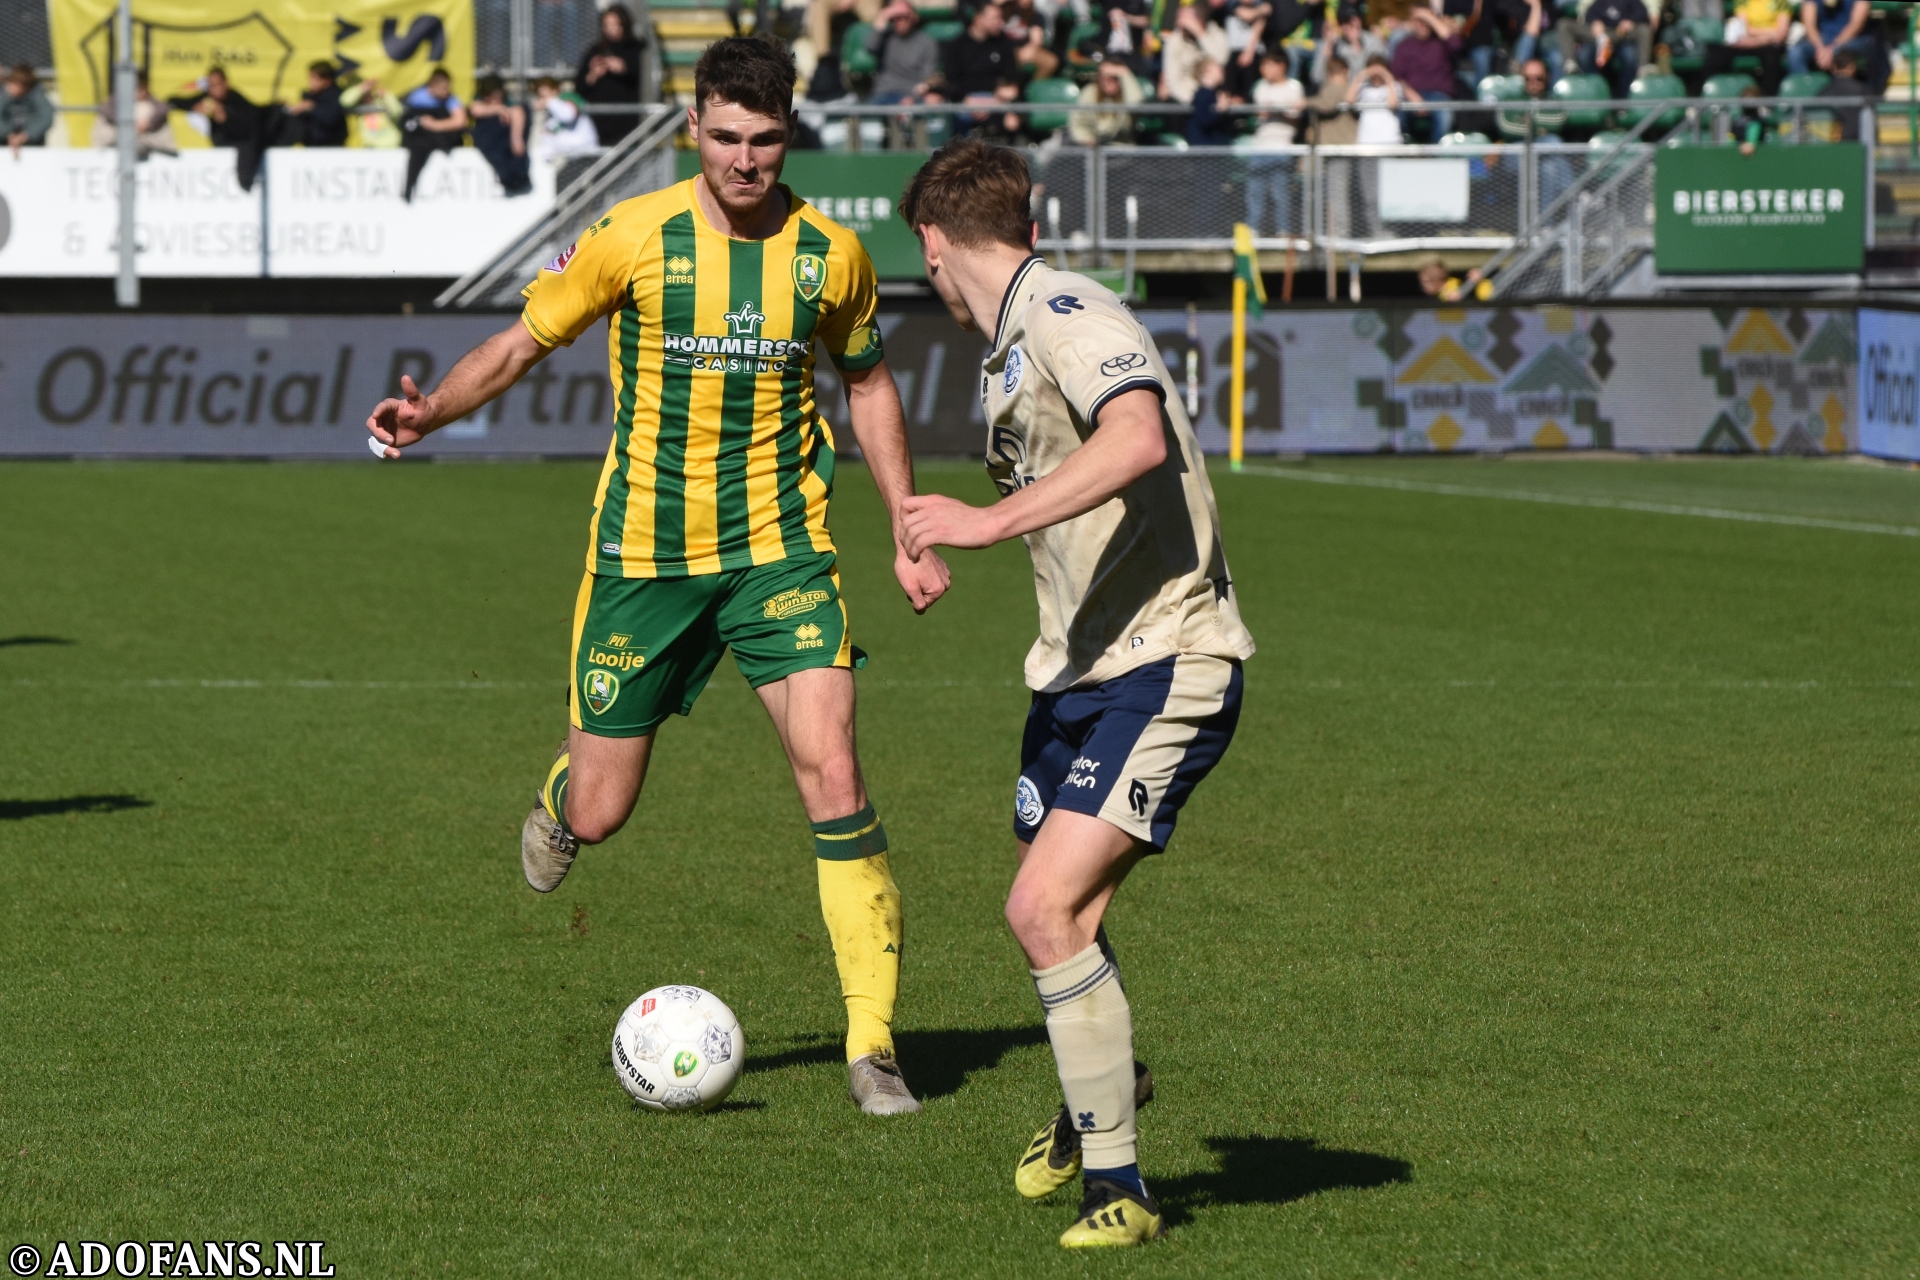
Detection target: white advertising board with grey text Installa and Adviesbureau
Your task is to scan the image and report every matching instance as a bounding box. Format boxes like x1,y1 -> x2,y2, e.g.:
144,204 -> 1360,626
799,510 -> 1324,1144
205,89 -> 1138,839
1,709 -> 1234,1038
0,148 -> 553,278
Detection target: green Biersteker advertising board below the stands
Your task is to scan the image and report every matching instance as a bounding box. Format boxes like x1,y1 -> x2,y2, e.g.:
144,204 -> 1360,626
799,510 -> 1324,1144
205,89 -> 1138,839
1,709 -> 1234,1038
1653,142 -> 1868,274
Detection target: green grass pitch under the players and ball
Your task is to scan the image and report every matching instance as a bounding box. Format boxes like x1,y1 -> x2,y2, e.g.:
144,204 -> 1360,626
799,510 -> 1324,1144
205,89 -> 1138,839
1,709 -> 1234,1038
0,459 -> 1920,1278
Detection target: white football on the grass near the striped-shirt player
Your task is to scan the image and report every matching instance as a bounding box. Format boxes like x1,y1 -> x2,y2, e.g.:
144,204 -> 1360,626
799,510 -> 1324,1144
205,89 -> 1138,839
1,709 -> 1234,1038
612,986 -> 747,1111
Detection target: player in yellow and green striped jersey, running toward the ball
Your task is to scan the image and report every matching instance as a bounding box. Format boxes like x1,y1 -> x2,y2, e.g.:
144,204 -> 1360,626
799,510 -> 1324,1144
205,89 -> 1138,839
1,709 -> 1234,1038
367,38 -> 947,1115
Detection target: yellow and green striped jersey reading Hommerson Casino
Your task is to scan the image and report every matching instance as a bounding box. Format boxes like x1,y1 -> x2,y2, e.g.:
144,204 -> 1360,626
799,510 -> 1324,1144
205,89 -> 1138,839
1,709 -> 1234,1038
520,177 -> 881,578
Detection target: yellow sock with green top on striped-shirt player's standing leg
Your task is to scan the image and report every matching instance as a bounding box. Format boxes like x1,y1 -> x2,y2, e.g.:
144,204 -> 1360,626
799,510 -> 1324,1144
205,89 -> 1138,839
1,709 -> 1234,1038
814,806 -> 904,1061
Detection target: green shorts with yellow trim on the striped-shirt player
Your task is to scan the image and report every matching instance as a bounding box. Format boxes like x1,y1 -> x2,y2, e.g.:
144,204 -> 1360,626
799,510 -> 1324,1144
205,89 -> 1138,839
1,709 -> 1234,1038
568,551 -> 866,737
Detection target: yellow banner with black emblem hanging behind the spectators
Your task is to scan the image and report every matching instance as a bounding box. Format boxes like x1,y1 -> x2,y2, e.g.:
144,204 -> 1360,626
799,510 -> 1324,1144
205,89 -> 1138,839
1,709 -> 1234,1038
48,0 -> 474,121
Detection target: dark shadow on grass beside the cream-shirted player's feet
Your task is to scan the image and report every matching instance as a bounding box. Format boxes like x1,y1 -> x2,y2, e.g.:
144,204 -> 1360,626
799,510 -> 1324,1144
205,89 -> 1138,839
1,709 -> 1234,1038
1150,1134 -> 1413,1224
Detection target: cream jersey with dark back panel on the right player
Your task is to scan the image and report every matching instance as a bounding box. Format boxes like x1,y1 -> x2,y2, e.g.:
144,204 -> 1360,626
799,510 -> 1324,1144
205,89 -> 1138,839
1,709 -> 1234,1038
979,257 -> 1254,693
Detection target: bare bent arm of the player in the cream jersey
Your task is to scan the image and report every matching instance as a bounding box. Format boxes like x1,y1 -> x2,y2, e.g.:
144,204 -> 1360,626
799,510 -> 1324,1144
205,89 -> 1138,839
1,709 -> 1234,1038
900,388 -> 1167,555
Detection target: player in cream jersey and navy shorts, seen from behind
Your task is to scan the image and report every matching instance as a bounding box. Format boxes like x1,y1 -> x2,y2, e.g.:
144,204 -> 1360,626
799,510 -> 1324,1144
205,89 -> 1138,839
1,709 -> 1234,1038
900,140 -> 1254,1247
